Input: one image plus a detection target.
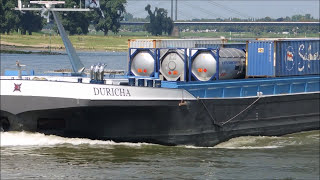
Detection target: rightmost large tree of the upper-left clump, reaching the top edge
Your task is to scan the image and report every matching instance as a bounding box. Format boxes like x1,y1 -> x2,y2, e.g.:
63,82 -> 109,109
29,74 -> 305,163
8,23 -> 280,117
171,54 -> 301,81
94,0 -> 127,35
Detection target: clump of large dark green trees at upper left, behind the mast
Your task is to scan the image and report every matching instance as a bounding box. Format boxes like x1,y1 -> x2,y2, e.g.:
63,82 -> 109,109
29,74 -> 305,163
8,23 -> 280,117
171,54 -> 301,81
0,0 -> 126,35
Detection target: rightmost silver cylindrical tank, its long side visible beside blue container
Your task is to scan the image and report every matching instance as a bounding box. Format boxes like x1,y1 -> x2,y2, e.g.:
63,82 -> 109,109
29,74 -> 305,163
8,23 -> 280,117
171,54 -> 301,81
190,48 -> 245,81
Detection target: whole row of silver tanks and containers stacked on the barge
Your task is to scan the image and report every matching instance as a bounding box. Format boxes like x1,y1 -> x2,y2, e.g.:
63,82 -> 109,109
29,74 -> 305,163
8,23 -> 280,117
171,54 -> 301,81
129,39 -> 320,86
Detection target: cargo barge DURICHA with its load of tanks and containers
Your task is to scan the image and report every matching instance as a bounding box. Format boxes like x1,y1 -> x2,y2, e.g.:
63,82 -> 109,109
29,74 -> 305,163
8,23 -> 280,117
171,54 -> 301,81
0,39 -> 320,146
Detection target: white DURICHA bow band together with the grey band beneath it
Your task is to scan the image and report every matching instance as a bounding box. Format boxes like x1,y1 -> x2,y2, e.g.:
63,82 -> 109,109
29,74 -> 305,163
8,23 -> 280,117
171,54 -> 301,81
0,79 -> 196,114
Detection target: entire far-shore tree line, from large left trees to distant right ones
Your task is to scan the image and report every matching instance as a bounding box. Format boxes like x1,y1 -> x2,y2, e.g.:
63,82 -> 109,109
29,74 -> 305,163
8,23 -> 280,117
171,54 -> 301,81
0,0 -> 320,36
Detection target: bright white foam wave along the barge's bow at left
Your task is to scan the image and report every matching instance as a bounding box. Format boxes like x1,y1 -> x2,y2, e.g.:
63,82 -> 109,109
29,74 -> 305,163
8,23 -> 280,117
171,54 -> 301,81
0,132 -> 148,147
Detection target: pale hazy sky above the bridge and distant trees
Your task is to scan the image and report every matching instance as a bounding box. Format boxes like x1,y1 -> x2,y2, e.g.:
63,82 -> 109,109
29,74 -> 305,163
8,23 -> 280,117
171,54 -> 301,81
126,0 -> 319,20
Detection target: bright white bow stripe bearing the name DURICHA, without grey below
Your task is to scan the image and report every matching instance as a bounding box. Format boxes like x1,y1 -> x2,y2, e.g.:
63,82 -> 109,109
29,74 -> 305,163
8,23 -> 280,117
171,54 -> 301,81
0,80 -> 195,100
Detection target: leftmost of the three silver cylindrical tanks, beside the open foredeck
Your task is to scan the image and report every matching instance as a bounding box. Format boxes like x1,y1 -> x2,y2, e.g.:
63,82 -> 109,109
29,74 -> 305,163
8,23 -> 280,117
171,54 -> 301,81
130,49 -> 156,76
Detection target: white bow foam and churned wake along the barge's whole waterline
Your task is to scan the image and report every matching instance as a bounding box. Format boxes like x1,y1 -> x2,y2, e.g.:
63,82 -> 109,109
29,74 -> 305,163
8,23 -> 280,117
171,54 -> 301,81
0,130 -> 320,149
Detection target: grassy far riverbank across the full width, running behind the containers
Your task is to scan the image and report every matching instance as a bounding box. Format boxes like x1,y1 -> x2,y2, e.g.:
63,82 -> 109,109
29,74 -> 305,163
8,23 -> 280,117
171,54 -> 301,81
0,32 -> 317,54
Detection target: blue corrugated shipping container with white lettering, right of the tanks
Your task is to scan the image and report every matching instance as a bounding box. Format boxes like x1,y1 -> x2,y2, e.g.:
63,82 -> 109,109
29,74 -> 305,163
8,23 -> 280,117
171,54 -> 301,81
246,39 -> 320,77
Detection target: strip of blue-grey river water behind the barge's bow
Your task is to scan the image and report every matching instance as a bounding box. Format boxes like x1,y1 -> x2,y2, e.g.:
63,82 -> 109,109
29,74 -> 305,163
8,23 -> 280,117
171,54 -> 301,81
0,52 -> 128,75
